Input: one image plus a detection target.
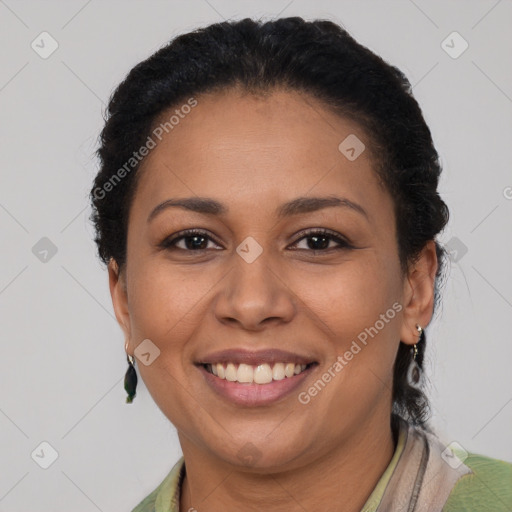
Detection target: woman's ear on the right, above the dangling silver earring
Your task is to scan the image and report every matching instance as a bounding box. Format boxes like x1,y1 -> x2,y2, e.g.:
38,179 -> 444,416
400,240 -> 438,345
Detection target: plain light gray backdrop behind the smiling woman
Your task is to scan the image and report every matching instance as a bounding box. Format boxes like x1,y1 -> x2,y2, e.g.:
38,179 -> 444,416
0,0 -> 512,512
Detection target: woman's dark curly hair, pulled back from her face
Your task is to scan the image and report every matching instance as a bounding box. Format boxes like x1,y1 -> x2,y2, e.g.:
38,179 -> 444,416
90,17 -> 449,431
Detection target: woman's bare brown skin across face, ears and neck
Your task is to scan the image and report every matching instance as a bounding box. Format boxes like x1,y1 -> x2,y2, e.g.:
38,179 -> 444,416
109,90 -> 437,512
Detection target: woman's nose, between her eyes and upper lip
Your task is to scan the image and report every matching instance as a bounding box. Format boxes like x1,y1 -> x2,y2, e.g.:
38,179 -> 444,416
214,252 -> 297,331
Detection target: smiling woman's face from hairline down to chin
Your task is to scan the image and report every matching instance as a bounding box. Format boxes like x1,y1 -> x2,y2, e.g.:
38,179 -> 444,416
109,86 -> 435,470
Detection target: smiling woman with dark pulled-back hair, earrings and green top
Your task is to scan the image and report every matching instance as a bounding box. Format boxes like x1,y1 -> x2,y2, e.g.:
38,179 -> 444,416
91,17 -> 512,512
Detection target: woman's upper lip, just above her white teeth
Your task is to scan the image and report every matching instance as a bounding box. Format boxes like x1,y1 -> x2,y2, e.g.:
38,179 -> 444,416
196,348 -> 316,365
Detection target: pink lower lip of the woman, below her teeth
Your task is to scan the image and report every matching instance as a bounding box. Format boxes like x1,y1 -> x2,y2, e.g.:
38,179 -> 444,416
197,364 -> 317,407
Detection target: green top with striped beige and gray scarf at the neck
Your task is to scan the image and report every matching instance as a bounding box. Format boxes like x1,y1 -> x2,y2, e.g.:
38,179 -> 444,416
132,420 -> 512,512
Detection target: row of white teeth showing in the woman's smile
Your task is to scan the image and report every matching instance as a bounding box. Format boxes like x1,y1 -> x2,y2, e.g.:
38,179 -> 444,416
207,363 -> 306,384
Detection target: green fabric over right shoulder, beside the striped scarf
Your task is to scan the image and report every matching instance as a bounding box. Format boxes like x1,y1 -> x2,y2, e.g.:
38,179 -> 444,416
443,453 -> 512,512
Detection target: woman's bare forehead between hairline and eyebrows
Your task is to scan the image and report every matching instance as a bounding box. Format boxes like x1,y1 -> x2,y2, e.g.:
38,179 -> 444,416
132,90 -> 389,226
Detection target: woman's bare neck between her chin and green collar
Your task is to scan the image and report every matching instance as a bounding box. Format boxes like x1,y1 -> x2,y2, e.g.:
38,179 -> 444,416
179,417 -> 395,512
